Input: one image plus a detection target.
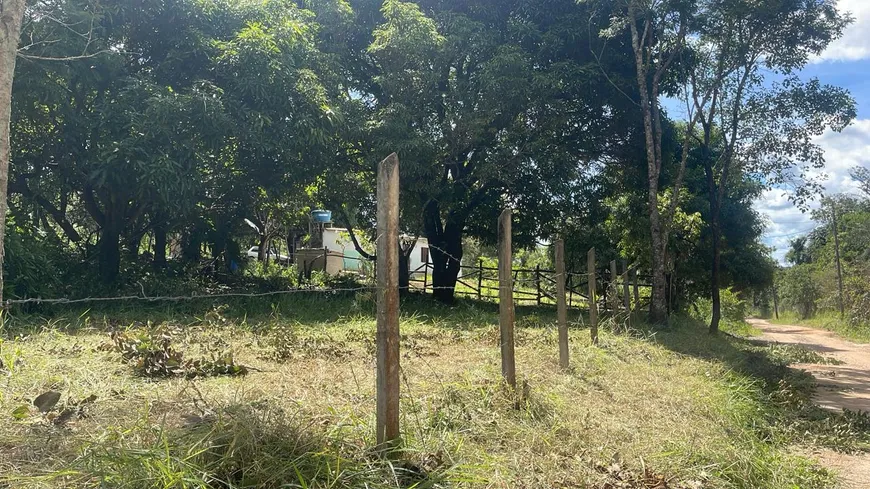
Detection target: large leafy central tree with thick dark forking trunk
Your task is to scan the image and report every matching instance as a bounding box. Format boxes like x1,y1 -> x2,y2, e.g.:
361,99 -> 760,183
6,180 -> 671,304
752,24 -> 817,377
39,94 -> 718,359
352,0 -> 625,301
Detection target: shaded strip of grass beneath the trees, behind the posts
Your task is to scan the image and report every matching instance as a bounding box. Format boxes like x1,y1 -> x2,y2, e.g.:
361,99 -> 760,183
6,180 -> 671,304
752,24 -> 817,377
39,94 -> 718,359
0,291 -> 581,336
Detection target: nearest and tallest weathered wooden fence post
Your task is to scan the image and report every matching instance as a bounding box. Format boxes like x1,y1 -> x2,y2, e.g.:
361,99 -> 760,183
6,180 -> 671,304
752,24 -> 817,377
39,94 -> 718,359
375,153 -> 399,446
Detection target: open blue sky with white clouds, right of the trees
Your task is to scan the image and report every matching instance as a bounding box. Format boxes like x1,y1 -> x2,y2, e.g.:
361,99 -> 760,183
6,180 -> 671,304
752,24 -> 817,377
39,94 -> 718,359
755,0 -> 870,261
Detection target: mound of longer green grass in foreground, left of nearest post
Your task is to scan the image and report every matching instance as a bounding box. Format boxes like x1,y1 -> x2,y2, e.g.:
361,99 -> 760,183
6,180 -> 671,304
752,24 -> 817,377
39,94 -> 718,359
8,403 -> 456,489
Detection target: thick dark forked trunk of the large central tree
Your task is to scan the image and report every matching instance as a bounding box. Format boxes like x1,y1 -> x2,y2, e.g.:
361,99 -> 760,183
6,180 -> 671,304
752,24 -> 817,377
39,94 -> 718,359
423,200 -> 465,304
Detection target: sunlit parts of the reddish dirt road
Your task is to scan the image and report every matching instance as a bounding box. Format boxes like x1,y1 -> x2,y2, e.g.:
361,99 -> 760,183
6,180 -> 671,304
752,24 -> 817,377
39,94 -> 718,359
749,319 -> 870,489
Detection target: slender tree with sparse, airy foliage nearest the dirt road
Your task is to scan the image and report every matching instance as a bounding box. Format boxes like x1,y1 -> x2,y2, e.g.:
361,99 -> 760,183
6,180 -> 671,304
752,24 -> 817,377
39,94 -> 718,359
683,0 -> 855,334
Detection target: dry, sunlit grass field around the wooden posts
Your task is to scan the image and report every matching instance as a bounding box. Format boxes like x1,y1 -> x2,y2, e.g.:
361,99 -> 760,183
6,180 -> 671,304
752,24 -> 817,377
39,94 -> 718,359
0,293 -> 870,489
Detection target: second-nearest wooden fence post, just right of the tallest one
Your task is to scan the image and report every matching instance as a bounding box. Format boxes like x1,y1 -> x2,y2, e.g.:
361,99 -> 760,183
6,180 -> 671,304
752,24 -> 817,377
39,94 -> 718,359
498,208 -> 517,388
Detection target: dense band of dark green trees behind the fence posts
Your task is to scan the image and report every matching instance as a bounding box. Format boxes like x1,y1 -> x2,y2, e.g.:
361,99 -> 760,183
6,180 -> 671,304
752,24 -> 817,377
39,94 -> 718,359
4,0 -> 860,330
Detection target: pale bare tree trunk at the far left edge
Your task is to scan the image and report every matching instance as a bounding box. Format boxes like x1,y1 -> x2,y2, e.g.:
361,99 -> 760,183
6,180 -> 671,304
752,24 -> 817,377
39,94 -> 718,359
0,0 -> 24,301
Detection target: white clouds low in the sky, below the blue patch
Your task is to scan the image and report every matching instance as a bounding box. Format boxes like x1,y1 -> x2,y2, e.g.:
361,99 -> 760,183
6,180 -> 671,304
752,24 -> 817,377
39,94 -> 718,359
755,119 -> 870,262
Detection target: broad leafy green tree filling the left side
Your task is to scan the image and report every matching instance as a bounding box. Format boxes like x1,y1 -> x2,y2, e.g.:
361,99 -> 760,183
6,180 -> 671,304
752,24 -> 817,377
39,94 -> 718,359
13,2 -> 341,283
